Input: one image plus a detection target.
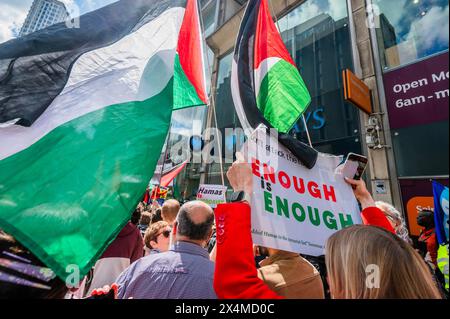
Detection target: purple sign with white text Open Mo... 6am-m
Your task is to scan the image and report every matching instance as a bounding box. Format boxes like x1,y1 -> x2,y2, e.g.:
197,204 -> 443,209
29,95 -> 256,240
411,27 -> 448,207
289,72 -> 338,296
384,52 -> 449,129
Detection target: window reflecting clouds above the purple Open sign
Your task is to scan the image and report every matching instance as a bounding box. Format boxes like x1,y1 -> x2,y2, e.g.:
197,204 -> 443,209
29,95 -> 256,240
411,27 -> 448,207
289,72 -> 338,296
373,0 -> 449,70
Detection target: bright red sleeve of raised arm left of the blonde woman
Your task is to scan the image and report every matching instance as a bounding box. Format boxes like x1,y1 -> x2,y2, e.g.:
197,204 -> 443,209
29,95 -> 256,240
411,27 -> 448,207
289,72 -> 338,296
214,203 -> 281,299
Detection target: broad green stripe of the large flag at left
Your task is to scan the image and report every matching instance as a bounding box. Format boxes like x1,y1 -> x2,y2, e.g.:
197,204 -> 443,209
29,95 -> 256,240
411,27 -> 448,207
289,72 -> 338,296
0,80 -> 173,279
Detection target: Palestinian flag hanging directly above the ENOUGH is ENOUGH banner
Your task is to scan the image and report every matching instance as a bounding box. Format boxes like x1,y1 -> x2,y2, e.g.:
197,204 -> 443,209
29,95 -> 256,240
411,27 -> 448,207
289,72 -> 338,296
231,0 -> 317,168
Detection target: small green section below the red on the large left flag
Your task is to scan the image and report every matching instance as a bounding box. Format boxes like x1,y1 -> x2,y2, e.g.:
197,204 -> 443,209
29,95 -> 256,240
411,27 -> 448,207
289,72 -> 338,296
173,54 -> 205,110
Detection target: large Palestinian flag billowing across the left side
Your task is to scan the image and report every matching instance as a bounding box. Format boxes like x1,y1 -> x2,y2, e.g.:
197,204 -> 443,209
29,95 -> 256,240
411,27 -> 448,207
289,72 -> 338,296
0,0 -> 206,279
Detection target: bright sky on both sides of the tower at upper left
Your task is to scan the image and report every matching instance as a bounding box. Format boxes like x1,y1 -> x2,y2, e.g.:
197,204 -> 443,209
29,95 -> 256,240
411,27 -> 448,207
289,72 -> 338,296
0,0 -> 117,43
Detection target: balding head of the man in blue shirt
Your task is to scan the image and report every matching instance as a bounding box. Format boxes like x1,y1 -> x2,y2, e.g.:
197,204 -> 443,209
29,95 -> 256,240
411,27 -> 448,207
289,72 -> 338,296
177,201 -> 214,241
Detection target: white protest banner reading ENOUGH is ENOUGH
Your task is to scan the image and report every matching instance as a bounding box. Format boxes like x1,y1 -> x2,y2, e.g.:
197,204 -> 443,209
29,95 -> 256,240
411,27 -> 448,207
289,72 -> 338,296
243,127 -> 361,256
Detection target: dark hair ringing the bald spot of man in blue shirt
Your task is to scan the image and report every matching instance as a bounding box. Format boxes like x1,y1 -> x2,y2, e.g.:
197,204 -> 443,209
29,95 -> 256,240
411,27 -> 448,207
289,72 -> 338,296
177,205 -> 214,240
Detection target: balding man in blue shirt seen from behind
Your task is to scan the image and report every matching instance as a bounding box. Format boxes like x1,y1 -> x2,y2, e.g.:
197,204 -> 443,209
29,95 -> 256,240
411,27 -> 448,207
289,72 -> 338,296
117,201 -> 217,299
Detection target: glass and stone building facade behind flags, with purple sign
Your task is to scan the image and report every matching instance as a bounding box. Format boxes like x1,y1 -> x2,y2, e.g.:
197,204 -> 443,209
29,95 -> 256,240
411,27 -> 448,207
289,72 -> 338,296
170,0 -> 449,235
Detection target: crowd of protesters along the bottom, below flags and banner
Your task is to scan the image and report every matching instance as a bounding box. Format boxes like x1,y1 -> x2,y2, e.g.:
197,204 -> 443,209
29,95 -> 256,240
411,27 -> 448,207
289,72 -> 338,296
0,163 -> 449,299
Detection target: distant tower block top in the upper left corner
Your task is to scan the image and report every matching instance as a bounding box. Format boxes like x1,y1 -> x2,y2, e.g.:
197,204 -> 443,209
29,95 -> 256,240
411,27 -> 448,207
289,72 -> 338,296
19,0 -> 69,36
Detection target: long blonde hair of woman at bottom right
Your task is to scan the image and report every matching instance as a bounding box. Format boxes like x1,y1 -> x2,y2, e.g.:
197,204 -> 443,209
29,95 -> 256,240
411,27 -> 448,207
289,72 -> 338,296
325,225 -> 442,299
